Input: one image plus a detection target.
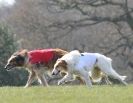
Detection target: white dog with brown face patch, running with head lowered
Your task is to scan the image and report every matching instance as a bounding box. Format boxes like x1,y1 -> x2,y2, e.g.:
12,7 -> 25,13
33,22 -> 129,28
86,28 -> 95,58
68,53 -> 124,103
52,50 -> 127,86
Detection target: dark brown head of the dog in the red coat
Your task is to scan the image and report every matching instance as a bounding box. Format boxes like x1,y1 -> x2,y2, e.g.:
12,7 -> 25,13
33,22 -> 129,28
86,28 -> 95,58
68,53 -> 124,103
5,50 -> 28,70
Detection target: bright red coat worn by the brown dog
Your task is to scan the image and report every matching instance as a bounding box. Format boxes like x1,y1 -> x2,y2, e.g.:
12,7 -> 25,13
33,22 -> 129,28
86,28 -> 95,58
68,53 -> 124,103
28,49 -> 54,64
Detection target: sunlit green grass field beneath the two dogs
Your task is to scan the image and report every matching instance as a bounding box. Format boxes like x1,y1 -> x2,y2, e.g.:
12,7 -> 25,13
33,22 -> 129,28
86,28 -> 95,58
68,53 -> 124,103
0,85 -> 133,103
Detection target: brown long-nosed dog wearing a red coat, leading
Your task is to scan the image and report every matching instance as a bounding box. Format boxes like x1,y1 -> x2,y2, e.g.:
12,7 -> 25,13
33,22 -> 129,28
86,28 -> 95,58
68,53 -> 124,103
5,48 -> 68,88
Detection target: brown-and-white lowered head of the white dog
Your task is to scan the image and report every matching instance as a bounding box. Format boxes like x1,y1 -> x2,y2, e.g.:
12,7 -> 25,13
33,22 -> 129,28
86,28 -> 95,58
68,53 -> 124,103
52,59 -> 67,75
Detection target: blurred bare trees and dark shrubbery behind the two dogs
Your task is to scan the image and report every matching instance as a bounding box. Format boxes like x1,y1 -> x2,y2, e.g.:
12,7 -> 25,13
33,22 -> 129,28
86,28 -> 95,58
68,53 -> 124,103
0,0 -> 133,86
